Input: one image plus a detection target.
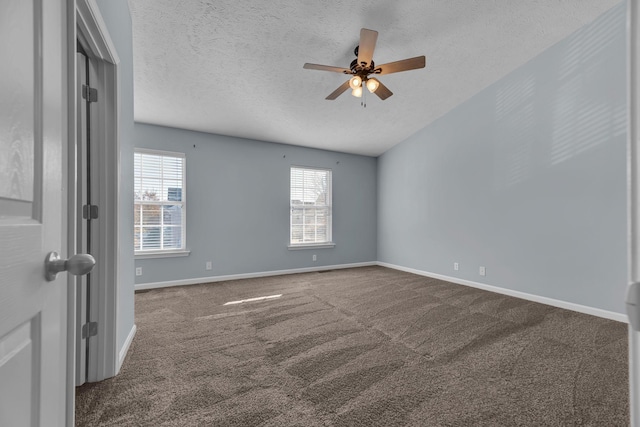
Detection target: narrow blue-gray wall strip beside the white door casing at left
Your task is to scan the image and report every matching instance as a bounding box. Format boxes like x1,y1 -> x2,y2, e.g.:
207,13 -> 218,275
97,0 -> 134,349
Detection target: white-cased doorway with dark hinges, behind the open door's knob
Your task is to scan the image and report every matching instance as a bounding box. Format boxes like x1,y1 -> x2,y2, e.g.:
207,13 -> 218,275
72,0 -> 126,385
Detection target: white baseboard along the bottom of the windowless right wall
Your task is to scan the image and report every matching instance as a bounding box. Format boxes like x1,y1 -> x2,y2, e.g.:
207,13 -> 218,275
378,261 -> 629,323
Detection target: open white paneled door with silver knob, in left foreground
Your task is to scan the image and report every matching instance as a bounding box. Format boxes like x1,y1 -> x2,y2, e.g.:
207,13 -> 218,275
0,0 -> 75,426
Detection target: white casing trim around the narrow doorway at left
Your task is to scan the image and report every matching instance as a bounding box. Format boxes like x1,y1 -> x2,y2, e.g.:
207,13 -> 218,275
74,0 -> 120,388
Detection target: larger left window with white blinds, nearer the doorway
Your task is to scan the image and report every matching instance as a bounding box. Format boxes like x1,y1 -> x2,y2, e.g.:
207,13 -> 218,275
134,150 -> 185,255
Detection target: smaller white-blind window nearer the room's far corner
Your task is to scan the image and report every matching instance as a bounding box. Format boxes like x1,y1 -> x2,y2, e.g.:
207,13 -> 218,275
290,166 -> 333,247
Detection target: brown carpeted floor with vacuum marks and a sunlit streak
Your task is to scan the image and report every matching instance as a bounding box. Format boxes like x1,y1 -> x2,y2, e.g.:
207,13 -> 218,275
76,267 -> 629,427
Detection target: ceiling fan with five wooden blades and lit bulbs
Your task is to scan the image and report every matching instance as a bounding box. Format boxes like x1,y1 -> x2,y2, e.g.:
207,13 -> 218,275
303,28 -> 426,101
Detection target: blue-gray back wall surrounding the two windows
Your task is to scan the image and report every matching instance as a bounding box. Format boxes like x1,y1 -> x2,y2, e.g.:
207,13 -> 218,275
129,123 -> 377,283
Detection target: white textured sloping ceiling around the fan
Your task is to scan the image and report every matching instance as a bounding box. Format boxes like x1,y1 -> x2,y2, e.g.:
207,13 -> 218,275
129,0 -> 618,156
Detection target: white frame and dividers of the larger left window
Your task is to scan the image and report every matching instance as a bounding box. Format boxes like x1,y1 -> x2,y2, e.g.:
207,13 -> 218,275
133,148 -> 190,259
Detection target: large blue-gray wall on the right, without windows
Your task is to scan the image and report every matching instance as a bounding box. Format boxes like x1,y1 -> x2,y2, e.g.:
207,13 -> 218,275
378,2 -> 627,313
